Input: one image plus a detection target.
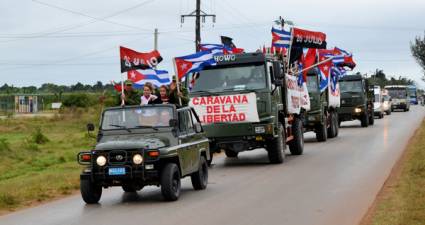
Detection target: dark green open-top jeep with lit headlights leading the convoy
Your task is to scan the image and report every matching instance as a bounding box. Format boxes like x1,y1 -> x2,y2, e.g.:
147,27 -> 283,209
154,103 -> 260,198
78,104 -> 210,204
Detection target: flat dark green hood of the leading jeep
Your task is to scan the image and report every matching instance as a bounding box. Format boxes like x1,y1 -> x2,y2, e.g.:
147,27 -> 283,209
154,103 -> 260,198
95,135 -> 170,150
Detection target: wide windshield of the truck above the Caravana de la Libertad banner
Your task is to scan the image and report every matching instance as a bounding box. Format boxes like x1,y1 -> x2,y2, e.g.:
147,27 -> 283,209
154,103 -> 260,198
189,63 -> 267,93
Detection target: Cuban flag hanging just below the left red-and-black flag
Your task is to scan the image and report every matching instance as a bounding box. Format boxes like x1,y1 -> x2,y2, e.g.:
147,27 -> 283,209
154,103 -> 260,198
127,69 -> 171,88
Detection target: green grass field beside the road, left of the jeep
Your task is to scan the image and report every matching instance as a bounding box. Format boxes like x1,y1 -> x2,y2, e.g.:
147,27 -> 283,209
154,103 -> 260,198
0,109 -> 100,212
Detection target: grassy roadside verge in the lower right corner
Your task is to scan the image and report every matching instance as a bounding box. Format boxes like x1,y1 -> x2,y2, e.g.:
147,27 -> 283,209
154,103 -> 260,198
370,120 -> 425,225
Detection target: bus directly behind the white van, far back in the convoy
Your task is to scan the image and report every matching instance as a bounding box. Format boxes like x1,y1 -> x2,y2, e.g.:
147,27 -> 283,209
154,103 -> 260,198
385,85 -> 410,112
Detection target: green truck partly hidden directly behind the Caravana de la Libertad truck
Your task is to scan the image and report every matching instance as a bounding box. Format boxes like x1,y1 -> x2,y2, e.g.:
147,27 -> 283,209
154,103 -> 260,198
304,69 -> 340,142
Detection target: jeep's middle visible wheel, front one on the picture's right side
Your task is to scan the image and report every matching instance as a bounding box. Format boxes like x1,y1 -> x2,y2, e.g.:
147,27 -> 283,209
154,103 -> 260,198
160,163 -> 181,201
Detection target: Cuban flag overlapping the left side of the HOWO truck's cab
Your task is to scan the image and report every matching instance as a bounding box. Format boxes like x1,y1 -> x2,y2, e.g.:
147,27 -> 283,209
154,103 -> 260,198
174,51 -> 217,80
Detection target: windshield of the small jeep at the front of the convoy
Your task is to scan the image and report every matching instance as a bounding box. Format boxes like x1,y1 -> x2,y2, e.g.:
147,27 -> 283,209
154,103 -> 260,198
101,107 -> 174,130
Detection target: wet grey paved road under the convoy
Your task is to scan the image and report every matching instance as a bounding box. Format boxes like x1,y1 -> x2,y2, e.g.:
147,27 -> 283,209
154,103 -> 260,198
0,107 -> 425,225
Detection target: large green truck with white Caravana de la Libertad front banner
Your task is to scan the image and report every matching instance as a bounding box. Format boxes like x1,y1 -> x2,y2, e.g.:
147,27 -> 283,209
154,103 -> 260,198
185,53 -> 309,163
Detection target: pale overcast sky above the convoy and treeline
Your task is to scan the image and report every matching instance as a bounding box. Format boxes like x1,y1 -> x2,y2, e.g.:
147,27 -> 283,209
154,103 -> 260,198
0,0 -> 425,88
